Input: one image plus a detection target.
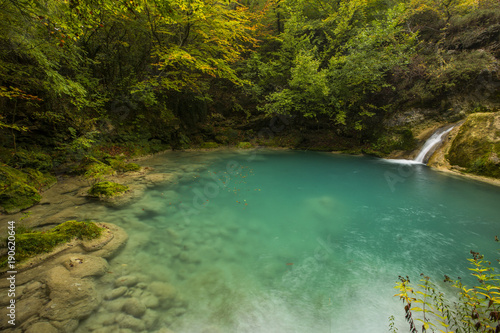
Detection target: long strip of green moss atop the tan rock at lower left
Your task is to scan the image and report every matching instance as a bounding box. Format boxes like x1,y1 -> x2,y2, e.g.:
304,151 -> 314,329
0,221 -> 103,267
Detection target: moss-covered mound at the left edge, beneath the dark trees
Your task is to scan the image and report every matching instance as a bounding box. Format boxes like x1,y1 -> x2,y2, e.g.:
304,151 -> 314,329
0,165 -> 53,214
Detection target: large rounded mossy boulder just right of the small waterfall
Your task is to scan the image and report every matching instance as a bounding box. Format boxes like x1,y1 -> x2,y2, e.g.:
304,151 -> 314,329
446,112 -> 500,178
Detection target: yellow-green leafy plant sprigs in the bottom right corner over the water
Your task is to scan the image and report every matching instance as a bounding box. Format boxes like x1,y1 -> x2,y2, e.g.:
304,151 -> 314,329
395,245 -> 500,333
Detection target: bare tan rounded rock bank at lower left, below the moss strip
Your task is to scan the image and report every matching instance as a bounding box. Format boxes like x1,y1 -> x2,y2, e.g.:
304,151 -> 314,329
0,223 -> 128,333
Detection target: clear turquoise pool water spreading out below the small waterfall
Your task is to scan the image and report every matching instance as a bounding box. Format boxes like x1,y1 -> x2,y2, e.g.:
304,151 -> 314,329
78,150 -> 500,333
